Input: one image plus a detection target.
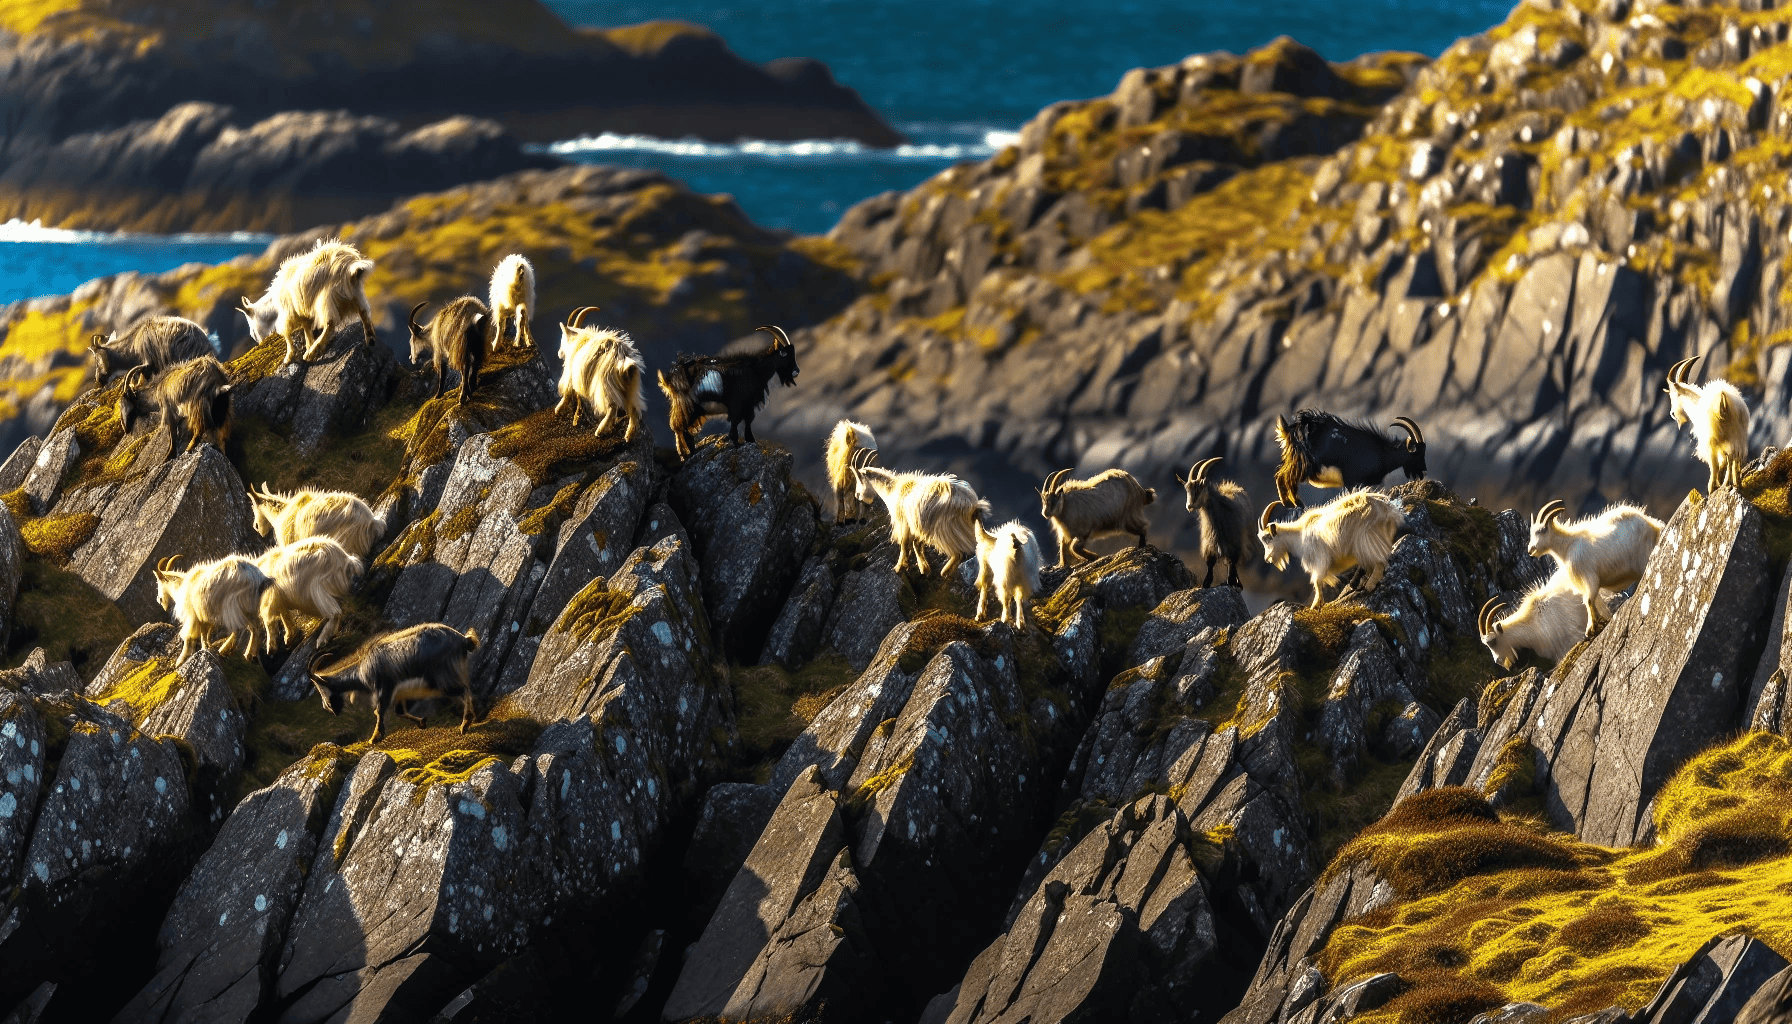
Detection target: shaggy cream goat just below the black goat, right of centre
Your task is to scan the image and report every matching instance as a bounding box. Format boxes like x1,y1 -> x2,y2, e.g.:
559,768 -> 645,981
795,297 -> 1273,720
1256,490 -> 1403,608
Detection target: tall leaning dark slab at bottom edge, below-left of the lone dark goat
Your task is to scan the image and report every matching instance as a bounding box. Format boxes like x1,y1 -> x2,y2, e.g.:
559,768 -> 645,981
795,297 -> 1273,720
118,748 -> 342,1022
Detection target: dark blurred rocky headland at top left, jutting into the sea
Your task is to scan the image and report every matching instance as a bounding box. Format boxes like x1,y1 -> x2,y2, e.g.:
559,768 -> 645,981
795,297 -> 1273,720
0,0 -> 901,231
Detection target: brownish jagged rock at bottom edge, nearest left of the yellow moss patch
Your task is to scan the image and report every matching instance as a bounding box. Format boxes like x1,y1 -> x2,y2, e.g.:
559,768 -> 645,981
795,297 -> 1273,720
923,796 -> 1217,1024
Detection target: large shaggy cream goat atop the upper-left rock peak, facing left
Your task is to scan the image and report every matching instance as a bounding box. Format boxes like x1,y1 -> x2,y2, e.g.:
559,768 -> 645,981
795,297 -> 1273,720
237,239 -> 375,364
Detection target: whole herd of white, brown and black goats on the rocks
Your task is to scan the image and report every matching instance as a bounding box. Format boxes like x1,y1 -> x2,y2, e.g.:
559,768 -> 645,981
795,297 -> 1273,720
90,240 -> 1749,741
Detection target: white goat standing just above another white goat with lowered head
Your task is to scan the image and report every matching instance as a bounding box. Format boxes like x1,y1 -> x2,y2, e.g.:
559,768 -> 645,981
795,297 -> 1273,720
1530,500 -> 1667,637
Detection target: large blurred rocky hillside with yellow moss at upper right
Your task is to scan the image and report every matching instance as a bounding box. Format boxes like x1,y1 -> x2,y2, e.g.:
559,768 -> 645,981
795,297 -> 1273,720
776,0 -> 1792,559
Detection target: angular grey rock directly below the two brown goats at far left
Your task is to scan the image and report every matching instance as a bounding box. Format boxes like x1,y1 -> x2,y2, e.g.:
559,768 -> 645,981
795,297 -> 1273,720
54,445 -> 262,622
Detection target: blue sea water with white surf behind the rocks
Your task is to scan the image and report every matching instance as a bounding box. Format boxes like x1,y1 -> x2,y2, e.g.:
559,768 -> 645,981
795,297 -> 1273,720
0,0 -> 1511,303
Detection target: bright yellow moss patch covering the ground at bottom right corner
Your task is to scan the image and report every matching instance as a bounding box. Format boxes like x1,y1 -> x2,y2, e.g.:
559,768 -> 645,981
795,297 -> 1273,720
1319,733 -> 1792,1024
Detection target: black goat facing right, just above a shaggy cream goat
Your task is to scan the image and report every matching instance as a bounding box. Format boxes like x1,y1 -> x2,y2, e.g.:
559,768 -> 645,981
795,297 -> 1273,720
1276,409 -> 1425,508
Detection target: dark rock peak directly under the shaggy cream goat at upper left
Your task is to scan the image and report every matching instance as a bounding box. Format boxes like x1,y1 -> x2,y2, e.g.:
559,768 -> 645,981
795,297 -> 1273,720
231,324 -> 400,457
